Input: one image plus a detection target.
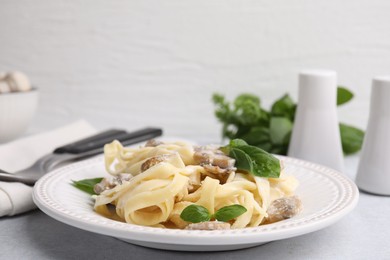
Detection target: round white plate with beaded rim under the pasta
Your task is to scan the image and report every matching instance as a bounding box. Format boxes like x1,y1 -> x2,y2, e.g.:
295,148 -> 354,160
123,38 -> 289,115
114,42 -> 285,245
33,157 -> 359,251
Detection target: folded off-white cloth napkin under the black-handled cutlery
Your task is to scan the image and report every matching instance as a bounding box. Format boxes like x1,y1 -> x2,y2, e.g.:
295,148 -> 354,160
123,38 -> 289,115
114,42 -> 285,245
0,120 -> 96,217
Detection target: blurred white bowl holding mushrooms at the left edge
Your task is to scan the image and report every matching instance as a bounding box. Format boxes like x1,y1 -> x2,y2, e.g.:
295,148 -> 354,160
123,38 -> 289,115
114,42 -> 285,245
0,89 -> 38,143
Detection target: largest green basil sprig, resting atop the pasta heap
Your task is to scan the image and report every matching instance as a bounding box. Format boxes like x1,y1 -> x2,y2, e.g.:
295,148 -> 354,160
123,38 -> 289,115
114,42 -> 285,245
225,139 -> 280,178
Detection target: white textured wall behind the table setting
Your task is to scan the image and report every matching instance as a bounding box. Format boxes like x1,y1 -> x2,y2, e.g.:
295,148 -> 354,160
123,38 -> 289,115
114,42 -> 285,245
0,0 -> 390,141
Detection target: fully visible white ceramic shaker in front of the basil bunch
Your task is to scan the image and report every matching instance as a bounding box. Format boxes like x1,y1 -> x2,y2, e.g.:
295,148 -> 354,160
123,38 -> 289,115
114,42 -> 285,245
288,70 -> 344,172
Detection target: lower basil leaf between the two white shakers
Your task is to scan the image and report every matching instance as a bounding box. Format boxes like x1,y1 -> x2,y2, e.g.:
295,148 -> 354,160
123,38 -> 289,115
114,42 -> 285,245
340,123 -> 364,155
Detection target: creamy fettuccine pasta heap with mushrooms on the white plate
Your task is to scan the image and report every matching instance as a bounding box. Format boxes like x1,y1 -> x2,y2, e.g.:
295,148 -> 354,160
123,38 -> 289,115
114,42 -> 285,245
94,141 -> 298,229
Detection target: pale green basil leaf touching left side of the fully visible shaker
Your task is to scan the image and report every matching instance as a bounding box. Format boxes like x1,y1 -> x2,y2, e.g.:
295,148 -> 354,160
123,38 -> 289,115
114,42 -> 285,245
269,117 -> 293,145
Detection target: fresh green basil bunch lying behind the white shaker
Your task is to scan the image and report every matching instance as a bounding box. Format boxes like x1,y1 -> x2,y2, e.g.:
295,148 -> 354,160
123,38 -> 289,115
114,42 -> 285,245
213,86 -> 364,155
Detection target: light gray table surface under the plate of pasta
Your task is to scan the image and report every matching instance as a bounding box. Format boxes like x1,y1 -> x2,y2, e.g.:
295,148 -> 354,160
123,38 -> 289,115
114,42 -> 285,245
0,150 -> 390,260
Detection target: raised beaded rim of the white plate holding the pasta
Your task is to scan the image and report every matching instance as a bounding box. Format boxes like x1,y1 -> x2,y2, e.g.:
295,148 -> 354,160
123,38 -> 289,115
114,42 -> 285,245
33,155 -> 359,246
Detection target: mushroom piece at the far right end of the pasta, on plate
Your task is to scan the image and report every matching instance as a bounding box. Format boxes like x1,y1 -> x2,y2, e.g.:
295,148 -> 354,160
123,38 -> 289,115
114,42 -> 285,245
265,196 -> 302,223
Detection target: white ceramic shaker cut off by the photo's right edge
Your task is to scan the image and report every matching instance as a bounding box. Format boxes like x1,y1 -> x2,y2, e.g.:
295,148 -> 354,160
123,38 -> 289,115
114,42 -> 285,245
356,76 -> 390,195
